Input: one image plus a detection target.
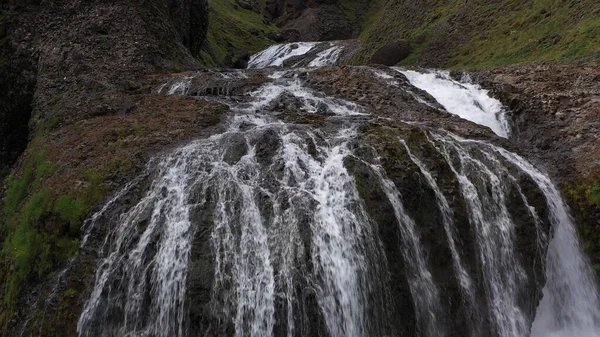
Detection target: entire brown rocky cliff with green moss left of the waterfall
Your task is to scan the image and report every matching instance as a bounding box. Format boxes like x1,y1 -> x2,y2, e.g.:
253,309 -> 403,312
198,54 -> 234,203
0,0 -> 212,336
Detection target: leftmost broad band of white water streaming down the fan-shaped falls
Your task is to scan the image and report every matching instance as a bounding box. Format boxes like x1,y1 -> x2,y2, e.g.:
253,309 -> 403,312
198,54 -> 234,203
78,140 -> 195,336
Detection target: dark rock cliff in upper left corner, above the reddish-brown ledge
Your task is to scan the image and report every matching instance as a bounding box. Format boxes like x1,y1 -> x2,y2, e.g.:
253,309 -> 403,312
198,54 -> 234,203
0,0 -> 208,172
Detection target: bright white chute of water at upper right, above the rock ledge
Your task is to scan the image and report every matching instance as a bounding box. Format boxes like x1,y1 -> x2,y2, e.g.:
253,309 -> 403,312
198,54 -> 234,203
396,68 -> 510,137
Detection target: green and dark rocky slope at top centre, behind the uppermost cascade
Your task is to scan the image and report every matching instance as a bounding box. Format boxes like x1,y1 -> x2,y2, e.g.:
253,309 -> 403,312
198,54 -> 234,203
199,0 -> 369,67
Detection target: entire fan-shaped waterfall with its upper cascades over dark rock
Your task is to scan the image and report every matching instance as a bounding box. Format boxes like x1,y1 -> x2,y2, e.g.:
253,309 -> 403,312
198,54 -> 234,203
78,43 -> 600,337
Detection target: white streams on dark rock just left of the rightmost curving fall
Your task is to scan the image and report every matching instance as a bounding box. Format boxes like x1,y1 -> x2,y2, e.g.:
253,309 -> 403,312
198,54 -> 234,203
434,135 -> 529,337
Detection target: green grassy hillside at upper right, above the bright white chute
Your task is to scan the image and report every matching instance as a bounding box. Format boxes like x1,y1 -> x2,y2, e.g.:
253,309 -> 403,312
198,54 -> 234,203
354,0 -> 600,67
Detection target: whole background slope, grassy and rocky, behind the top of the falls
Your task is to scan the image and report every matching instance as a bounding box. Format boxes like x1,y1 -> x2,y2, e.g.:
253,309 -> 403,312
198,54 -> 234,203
207,0 -> 600,68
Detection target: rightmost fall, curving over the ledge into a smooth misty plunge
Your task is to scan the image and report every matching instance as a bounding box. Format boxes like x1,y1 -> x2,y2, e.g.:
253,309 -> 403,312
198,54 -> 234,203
434,135 -> 600,337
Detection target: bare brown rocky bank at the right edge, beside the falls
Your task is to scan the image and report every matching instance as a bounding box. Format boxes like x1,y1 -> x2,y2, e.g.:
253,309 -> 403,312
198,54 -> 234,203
473,64 -> 600,279
